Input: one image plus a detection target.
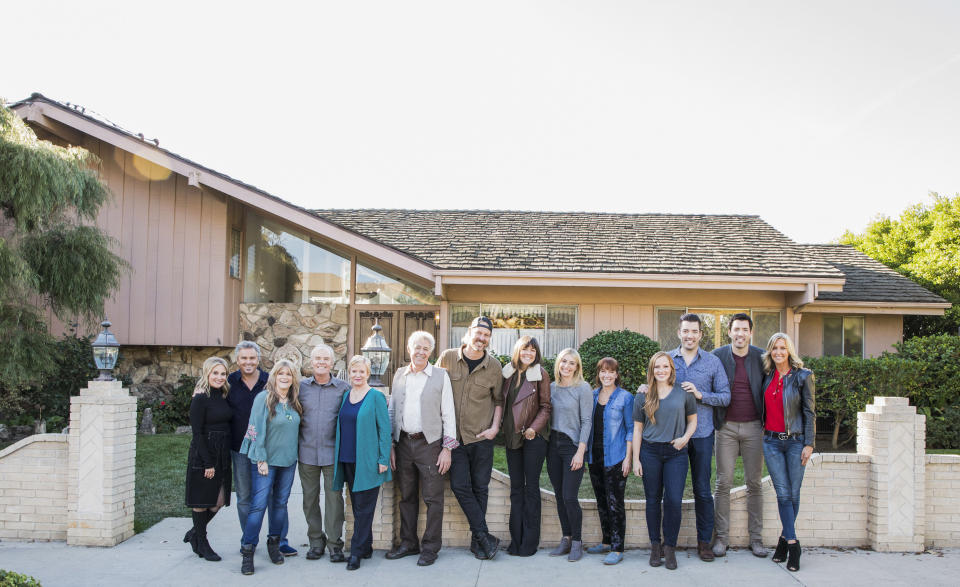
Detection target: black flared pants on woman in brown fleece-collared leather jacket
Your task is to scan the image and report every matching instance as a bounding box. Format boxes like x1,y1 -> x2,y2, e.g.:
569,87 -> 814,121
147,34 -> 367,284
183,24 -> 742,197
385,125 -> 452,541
507,435 -> 547,556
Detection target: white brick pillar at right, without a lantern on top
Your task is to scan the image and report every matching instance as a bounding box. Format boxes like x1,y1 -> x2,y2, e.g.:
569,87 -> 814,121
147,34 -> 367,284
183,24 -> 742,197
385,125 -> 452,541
857,397 -> 926,552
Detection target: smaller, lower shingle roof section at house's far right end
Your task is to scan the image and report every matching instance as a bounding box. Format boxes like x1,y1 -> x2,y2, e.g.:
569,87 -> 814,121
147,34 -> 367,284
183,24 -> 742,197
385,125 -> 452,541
804,245 -> 946,303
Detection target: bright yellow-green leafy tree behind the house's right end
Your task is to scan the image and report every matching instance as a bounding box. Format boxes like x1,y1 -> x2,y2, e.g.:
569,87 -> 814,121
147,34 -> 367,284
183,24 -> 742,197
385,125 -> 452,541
840,192 -> 960,338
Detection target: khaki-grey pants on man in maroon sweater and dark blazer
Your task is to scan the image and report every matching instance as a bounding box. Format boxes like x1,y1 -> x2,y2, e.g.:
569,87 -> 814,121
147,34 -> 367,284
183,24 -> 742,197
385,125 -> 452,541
714,420 -> 763,545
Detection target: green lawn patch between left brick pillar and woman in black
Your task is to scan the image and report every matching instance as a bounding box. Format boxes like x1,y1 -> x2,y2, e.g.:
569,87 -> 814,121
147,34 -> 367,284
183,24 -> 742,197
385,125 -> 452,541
133,434 -> 190,534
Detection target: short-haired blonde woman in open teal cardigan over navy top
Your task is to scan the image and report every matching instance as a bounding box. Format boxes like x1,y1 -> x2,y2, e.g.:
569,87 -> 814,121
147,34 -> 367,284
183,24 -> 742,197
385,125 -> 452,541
333,355 -> 392,571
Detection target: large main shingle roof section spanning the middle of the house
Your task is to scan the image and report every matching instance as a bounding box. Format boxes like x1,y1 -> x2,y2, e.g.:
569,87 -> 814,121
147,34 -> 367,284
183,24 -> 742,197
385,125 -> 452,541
314,209 -> 843,279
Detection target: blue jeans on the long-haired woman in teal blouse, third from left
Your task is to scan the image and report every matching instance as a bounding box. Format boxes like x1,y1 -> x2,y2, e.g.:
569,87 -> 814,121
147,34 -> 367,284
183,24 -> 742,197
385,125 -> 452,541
242,461 -> 297,546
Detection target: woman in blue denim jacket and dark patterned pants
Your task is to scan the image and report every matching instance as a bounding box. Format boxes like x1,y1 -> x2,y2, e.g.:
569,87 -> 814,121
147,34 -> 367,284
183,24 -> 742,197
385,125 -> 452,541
587,357 -> 633,565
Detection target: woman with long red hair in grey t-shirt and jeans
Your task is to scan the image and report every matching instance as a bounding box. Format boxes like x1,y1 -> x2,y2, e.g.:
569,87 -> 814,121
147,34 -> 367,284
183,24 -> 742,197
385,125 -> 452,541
633,352 -> 697,570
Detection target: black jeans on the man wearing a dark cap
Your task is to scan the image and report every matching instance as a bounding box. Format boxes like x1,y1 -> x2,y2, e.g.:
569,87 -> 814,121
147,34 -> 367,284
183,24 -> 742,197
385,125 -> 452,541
450,440 -> 493,534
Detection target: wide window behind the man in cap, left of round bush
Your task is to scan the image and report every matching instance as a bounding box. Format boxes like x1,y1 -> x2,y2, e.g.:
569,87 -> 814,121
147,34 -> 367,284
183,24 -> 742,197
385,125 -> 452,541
450,304 -> 577,357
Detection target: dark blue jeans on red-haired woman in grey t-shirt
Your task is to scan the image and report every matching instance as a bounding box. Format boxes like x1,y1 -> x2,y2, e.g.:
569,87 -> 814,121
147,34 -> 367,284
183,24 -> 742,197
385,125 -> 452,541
640,441 -> 687,546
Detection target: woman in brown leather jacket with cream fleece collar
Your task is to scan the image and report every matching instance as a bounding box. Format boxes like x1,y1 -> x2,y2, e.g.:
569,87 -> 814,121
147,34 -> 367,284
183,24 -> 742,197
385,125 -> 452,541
503,336 -> 551,556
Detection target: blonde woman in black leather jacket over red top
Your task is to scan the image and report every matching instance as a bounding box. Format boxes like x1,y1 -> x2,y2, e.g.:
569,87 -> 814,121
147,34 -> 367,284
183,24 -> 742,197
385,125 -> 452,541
762,332 -> 816,571
